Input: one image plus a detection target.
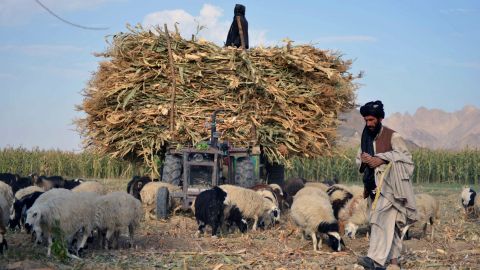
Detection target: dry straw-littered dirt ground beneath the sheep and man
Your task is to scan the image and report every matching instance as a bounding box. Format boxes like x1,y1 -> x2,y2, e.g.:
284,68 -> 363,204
0,180 -> 480,270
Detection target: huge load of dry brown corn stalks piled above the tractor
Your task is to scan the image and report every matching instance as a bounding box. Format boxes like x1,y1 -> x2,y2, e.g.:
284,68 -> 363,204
77,26 -> 357,174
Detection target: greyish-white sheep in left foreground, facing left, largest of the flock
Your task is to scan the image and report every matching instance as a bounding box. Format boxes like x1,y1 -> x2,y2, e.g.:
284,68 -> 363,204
26,192 -> 98,257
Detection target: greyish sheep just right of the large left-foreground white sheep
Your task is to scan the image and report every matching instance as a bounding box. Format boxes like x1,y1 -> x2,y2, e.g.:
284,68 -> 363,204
94,191 -> 143,249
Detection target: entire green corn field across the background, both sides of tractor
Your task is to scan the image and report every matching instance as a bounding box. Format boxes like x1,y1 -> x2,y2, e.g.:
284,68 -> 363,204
0,148 -> 480,185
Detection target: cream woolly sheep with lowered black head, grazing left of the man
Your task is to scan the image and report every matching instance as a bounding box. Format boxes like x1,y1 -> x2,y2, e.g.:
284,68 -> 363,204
290,193 -> 343,251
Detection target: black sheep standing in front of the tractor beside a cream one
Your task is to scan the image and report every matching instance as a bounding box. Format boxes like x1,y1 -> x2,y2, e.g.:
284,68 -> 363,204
195,187 -> 233,236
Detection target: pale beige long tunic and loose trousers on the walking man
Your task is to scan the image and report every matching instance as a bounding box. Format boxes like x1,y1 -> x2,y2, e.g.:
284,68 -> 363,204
356,126 -> 417,266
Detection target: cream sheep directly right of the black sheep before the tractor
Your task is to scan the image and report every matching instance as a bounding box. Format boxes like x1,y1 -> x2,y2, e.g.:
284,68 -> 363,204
219,185 -> 280,231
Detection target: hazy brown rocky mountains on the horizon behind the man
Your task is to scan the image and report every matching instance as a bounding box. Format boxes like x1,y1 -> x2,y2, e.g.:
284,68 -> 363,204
337,106 -> 480,150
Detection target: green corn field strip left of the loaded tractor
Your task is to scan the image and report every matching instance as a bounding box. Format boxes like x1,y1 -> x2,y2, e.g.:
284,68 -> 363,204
0,148 -> 145,178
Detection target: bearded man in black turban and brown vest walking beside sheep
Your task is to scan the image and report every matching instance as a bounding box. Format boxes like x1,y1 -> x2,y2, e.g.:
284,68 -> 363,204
357,100 -> 417,269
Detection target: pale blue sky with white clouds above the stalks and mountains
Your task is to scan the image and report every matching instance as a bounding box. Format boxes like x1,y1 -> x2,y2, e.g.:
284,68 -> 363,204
0,0 -> 480,151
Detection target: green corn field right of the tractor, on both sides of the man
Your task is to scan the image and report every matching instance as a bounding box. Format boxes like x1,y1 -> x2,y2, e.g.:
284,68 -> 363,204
286,149 -> 480,185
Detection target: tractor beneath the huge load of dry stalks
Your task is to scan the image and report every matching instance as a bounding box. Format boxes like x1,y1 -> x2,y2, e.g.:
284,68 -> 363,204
156,110 -> 284,219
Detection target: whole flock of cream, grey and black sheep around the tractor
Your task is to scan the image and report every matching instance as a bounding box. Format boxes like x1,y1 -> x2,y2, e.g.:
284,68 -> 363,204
0,173 -> 480,258
